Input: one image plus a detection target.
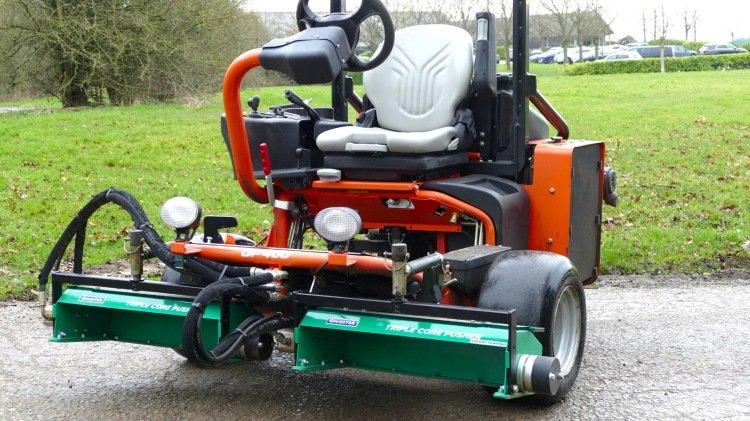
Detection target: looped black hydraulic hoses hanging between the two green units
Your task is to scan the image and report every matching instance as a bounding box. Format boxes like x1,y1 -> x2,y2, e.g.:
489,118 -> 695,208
182,273 -> 293,367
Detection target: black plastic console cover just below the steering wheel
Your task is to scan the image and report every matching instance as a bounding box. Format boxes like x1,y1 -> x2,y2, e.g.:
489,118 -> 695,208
260,26 -> 352,84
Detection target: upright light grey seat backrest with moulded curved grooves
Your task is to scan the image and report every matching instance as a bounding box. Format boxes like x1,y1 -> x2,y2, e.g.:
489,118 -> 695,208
363,25 -> 474,132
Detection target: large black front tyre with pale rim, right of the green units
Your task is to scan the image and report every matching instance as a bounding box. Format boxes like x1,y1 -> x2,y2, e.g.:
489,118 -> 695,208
477,251 -> 586,405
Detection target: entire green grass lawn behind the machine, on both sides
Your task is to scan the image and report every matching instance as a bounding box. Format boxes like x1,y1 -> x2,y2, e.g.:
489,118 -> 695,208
0,69 -> 750,297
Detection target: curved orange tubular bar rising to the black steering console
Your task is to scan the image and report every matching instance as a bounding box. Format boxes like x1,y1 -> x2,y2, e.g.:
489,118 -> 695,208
223,48 -> 268,203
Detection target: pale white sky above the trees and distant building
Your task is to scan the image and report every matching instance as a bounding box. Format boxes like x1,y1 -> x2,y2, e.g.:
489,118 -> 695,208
248,0 -> 750,42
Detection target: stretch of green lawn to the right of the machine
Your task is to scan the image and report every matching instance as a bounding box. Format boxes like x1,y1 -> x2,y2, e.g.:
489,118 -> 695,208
539,71 -> 750,272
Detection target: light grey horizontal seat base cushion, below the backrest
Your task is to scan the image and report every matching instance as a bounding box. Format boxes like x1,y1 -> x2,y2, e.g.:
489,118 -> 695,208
317,126 -> 458,153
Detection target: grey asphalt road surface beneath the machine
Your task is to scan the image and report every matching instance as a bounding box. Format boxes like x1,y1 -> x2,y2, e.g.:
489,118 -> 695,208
0,271 -> 750,420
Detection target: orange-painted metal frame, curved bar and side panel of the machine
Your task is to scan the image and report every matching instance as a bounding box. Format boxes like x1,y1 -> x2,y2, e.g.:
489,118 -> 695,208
171,49 -> 604,303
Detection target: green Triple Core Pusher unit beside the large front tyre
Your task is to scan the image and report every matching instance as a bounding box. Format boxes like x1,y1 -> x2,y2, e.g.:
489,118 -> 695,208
293,309 -> 542,388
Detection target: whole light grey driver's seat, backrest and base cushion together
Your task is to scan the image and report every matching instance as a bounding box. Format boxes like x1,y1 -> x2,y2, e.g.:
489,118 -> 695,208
316,25 -> 474,153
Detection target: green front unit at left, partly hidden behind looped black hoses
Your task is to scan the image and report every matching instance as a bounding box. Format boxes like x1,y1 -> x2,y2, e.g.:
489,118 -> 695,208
51,286 -> 255,349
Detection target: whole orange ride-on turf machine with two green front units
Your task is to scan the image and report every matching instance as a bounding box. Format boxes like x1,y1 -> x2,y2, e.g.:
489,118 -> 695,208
39,0 -> 617,403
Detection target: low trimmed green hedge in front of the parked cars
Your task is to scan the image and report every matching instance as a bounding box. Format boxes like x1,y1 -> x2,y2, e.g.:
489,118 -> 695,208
563,53 -> 750,76
